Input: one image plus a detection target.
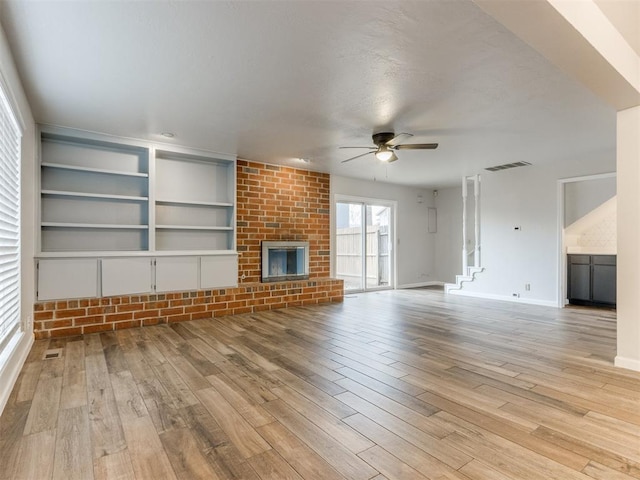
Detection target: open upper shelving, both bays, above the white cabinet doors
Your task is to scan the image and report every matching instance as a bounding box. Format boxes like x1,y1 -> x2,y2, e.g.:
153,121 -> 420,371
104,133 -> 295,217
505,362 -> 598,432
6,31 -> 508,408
39,127 -> 237,263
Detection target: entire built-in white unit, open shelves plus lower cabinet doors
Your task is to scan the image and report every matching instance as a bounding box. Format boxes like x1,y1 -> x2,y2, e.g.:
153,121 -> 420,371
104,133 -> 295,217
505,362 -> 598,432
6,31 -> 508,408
37,127 -> 238,299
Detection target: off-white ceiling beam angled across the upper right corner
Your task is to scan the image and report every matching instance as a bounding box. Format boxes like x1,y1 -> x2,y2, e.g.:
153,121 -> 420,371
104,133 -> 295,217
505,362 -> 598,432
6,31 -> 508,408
474,0 -> 640,110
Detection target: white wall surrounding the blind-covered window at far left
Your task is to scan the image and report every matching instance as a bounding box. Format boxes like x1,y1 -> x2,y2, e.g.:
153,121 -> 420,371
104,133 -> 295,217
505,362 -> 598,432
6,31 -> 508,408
0,19 -> 38,413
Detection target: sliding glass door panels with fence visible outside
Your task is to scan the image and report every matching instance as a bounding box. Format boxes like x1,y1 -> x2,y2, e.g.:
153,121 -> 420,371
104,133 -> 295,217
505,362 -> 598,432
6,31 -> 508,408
335,201 -> 394,292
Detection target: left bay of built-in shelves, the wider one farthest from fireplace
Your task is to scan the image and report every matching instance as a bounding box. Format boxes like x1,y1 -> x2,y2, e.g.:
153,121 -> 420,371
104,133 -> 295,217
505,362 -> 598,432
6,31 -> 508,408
40,132 -> 149,252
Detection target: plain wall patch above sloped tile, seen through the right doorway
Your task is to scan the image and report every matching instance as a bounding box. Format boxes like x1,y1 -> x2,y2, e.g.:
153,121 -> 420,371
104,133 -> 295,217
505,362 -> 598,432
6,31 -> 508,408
564,177 -> 616,227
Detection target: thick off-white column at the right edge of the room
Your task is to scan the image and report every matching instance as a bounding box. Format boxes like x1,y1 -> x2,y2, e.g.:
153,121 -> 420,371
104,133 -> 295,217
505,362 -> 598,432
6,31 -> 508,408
615,106 -> 640,371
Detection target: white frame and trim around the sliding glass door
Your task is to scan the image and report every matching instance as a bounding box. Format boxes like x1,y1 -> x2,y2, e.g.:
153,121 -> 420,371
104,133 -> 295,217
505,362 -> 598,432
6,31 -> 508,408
330,193 -> 398,293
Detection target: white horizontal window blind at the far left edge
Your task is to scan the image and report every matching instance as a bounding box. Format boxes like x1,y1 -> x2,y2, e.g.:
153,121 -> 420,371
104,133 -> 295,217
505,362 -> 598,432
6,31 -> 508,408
0,83 -> 21,352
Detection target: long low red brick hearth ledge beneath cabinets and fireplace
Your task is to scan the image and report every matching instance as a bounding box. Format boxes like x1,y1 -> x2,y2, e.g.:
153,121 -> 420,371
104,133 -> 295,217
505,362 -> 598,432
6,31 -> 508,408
34,278 -> 344,339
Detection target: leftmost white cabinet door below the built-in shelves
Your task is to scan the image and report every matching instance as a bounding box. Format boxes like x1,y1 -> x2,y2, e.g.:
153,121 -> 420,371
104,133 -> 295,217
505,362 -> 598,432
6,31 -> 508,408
38,258 -> 99,301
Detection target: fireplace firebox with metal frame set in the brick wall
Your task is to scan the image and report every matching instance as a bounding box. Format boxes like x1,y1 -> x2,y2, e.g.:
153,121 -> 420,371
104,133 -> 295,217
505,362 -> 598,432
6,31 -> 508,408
262,241 -> 309,282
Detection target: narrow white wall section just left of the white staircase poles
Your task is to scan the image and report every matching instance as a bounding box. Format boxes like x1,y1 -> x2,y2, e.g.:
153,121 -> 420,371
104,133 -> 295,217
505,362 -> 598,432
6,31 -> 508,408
434,187 -> 462,283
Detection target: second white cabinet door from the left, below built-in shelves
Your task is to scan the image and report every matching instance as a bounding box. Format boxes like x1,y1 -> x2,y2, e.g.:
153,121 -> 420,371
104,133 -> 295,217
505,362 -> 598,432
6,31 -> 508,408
102,258 -> 152,297
